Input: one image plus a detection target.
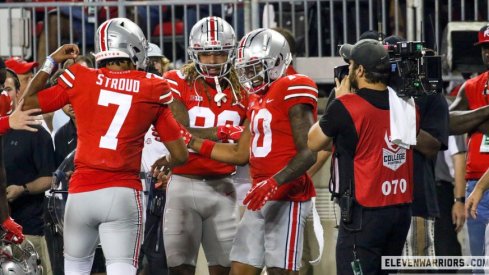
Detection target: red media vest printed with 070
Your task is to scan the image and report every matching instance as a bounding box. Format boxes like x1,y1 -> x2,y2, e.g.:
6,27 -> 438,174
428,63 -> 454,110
338,94 -> 413,207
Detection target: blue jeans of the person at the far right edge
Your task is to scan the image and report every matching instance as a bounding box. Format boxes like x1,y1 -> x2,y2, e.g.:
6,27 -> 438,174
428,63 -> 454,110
465,180 -> 489,256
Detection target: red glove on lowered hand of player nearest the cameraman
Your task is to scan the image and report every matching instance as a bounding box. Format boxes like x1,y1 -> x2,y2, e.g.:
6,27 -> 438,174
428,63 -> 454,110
243,178 -> 278,211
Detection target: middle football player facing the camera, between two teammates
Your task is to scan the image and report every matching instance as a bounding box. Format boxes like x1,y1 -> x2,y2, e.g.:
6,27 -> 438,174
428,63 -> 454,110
163,16 -> 247,275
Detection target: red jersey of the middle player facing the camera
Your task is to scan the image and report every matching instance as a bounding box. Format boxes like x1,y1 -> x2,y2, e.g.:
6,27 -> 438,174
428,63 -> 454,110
165,70 -> 248,175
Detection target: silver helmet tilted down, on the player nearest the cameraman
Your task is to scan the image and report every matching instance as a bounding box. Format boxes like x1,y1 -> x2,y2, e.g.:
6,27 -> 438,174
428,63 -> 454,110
235,29 -> 292,94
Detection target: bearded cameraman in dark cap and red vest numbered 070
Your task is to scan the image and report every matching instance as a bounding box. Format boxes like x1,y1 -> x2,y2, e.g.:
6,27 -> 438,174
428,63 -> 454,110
308,39 -> 416,274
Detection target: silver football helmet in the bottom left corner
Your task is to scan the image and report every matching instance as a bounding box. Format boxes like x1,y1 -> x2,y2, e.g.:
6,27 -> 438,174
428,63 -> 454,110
0,240 -> 42,275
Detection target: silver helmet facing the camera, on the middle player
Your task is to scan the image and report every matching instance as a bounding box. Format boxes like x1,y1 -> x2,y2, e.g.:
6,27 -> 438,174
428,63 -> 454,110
187,16 -> 236,77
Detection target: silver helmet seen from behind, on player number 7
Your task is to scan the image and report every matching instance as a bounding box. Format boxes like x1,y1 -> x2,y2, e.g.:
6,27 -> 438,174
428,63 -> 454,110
95,18 -> 148,69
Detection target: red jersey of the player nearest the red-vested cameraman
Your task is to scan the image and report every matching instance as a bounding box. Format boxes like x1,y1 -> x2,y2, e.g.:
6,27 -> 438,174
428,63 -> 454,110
248,74 -> 318,201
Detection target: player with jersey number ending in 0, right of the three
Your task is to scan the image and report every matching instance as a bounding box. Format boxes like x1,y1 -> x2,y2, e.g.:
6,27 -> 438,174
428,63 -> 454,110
160,29 -> 318,274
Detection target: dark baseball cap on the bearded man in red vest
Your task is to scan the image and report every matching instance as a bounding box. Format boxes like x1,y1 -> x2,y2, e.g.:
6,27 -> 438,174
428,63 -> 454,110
340,39 -> 390,73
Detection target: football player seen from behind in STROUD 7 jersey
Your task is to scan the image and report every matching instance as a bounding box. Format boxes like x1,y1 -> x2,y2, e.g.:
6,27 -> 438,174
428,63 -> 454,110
19,18 -> 188,275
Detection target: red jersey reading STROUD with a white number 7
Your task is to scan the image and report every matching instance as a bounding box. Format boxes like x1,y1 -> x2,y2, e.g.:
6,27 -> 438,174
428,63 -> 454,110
38,64 -> 180,193
